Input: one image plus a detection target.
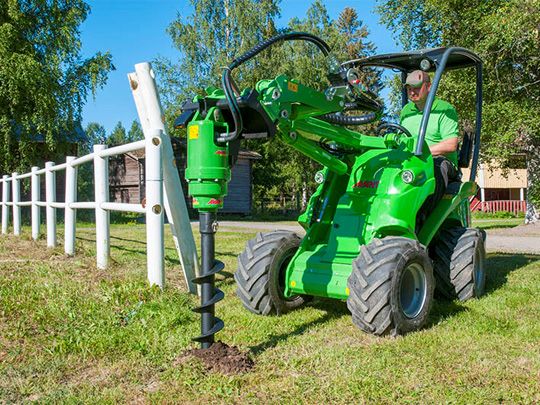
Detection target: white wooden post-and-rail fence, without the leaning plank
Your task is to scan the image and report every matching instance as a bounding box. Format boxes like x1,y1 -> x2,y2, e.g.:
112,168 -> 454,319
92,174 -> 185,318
0,134 -> 164,288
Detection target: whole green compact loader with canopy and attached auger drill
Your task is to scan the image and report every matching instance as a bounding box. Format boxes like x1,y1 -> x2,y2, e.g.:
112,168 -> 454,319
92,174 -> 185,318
180,32 -> 485,347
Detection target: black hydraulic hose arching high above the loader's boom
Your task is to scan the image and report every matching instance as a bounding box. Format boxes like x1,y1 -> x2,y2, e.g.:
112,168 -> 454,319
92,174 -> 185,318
217,32 -> 330,142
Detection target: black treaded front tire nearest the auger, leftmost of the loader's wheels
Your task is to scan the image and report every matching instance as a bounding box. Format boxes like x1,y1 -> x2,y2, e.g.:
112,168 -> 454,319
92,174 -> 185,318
234,231 -> 307,315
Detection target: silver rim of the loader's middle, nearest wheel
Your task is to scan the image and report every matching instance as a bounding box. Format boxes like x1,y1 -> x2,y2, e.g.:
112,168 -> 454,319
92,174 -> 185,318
399,263 -> 427,319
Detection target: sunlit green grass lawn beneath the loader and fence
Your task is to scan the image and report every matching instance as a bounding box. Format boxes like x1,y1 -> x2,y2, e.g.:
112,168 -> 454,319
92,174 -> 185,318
0,225 -> 540,403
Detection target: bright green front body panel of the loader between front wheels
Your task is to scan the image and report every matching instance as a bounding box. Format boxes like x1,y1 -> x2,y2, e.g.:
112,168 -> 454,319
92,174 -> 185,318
285,138 -> 446,299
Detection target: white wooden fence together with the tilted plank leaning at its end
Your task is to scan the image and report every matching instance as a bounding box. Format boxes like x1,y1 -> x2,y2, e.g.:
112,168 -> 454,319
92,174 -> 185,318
0,62 -> 199,294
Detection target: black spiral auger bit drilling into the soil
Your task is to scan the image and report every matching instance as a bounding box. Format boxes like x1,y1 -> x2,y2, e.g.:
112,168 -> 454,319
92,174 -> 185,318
193,212 -> 225,349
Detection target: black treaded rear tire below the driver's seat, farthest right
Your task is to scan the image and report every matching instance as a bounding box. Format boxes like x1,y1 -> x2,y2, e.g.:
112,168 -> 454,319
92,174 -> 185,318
430,228 -> 486,301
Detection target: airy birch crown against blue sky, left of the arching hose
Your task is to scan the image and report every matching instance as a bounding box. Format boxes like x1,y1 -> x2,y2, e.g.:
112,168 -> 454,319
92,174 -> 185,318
155,0 -> 279,117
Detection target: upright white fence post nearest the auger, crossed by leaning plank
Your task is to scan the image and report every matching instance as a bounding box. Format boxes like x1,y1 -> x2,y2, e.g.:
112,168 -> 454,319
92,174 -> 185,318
145,131 -> 165,289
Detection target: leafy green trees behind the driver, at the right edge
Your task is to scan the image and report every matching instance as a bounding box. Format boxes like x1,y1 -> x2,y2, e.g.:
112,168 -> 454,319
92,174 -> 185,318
378,0 -> 540,203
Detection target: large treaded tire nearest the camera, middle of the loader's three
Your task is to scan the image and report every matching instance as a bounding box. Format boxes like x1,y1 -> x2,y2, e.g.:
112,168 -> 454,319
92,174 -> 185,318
347,236 -> 435,336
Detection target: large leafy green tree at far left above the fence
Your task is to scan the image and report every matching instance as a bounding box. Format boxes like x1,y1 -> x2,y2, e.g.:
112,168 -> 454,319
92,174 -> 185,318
0,0 -> 113,173
